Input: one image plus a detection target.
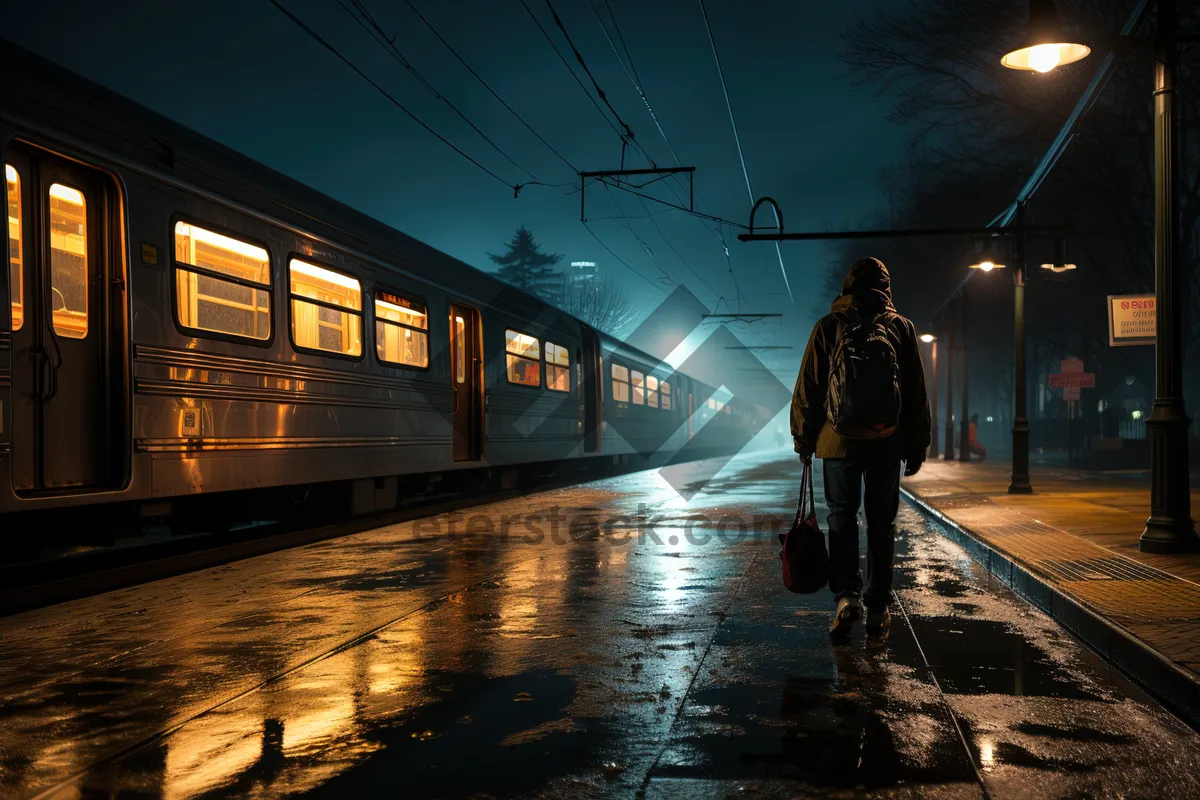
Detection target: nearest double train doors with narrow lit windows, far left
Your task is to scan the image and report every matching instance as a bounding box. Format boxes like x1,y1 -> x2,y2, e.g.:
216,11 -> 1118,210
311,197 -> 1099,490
5,149 -> 126,492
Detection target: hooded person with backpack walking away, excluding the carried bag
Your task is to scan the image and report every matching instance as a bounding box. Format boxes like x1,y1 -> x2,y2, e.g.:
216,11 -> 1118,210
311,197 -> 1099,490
791,258 -> 930,637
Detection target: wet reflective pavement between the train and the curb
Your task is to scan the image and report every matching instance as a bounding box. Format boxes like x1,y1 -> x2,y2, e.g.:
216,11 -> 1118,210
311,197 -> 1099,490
0,452 -> 1200,799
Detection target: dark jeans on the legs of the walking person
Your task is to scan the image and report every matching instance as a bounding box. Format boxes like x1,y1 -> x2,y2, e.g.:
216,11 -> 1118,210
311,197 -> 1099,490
822,449 -> 900,612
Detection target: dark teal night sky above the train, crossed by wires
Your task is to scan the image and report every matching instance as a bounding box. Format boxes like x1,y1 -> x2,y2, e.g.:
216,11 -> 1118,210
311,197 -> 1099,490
0,0 -> 905,380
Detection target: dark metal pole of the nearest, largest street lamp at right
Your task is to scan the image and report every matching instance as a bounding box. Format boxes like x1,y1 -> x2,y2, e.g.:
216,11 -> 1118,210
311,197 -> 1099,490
1138,0 -> 1200,553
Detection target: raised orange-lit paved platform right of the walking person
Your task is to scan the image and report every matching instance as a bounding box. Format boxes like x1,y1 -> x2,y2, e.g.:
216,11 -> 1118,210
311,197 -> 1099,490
905,461 -> 1200,724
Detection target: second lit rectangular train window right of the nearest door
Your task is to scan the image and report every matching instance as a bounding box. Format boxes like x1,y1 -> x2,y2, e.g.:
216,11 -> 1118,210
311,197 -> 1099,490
288,258 -> 362,356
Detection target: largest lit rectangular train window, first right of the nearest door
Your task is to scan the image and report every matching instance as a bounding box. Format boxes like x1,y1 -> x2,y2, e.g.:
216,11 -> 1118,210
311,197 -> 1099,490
175,222 -> 271,341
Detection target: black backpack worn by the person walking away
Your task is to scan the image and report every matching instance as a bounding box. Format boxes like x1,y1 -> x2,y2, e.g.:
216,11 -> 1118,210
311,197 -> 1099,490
826,312 -> 900,439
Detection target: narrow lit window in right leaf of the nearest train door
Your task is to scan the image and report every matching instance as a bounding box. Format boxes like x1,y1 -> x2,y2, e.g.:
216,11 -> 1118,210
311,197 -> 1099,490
49,184 -> 88,339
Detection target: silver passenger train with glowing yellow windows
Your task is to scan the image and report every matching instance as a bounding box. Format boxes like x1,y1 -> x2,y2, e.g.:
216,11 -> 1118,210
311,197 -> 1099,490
0,42 -> 757,522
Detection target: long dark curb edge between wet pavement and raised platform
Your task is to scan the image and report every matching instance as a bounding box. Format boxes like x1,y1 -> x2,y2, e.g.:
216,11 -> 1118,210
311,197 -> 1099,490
900,487 -> 1200,730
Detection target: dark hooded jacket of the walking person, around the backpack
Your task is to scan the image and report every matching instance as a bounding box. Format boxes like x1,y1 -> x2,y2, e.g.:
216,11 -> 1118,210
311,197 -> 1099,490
792,258 -> 930,462
